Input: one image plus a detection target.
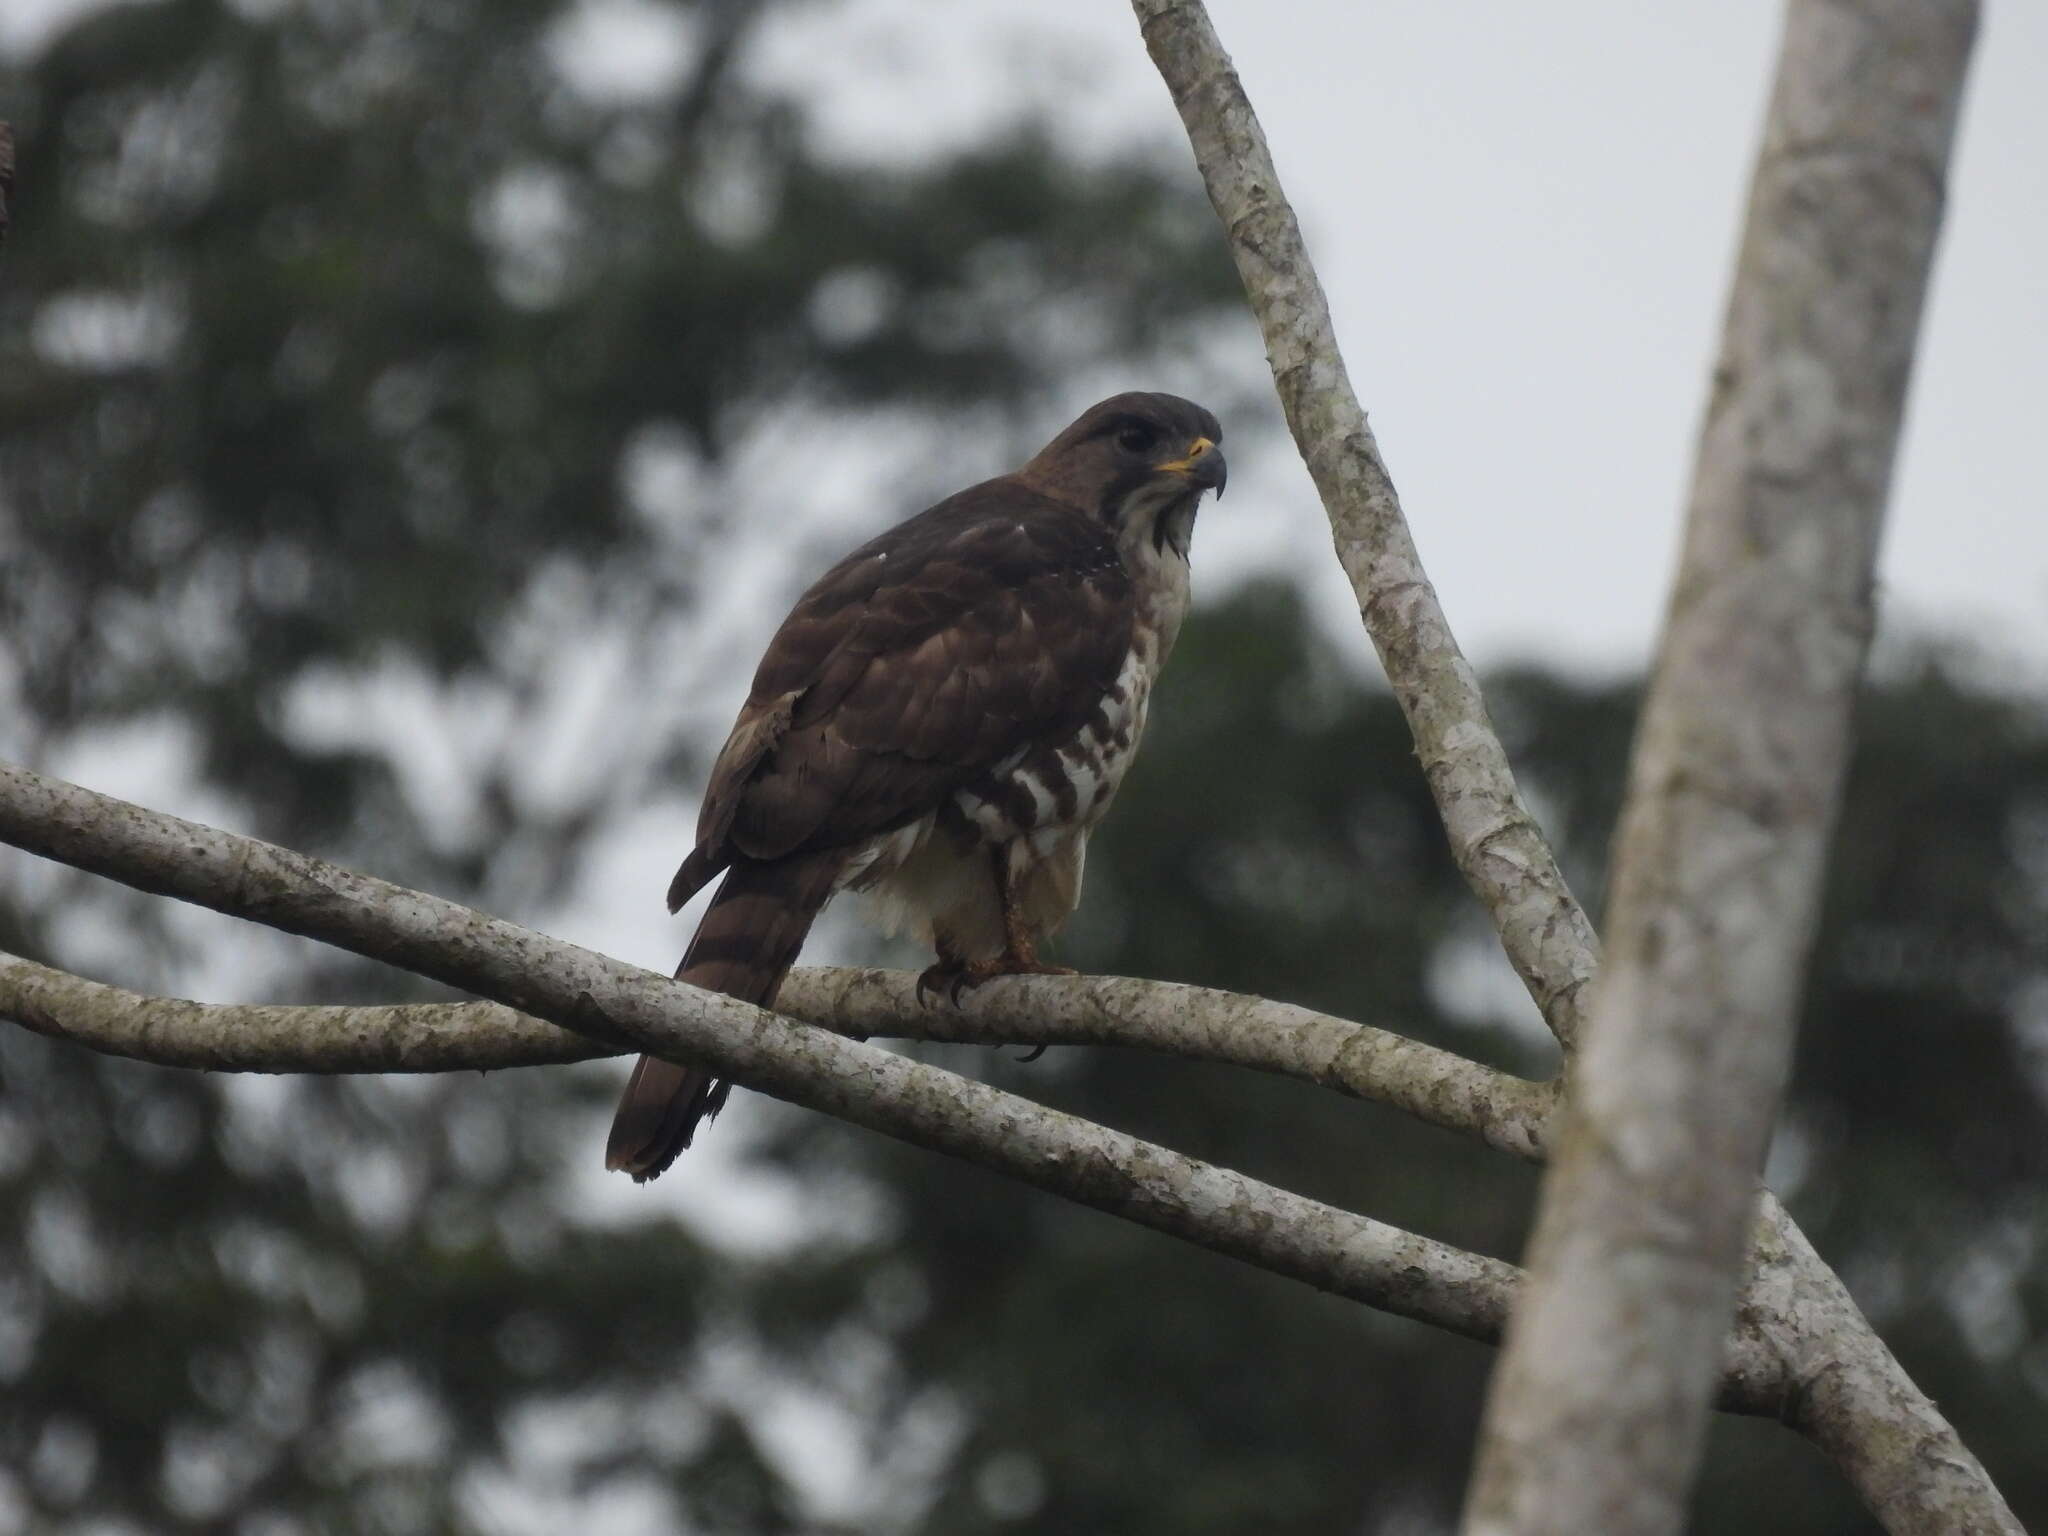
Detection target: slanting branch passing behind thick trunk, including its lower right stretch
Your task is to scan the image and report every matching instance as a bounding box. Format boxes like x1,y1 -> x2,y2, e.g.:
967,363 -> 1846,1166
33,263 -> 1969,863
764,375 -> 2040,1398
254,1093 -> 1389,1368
1133,0 -> 2017,1532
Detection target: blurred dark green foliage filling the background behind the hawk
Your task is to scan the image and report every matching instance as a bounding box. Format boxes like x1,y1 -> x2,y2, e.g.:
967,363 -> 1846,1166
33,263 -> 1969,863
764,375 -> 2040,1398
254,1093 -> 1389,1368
0,0 -> 2048,1536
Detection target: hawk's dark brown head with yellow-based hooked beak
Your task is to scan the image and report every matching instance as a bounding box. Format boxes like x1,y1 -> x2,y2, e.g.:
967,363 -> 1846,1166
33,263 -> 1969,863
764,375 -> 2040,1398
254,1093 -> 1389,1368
1018,393 -> 1227,557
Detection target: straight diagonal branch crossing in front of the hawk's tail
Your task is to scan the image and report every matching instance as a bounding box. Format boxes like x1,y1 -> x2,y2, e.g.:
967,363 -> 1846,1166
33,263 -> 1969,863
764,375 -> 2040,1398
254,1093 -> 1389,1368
0,764 -> 1523,1343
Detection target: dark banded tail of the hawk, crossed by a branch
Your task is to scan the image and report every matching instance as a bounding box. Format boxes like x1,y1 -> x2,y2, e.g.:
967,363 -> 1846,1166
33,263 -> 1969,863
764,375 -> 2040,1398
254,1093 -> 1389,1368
604,854 -> 840,1182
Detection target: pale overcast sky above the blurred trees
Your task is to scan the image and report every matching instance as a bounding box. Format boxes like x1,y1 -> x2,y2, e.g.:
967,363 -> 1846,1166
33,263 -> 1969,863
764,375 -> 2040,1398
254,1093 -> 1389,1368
737,0 -> 2048,680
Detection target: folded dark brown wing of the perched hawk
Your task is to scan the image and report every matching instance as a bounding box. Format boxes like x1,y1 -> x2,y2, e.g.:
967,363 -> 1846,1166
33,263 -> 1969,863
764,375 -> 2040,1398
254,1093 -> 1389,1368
670,477 -> 1130,905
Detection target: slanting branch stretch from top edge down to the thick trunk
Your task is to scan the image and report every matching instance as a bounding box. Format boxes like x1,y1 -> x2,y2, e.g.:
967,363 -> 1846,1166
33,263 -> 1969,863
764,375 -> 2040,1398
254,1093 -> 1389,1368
1133,0 -> 1599,1047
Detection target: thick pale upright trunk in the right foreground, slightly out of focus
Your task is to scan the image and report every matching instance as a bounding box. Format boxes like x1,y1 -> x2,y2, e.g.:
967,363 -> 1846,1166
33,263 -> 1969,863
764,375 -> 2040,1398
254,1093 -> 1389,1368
1466,0 -> 1976,1536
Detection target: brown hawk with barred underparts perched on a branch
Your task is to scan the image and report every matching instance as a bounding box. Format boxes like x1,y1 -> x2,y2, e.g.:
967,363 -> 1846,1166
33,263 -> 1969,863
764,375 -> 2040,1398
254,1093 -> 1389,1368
604,393 -> 1225,1180
